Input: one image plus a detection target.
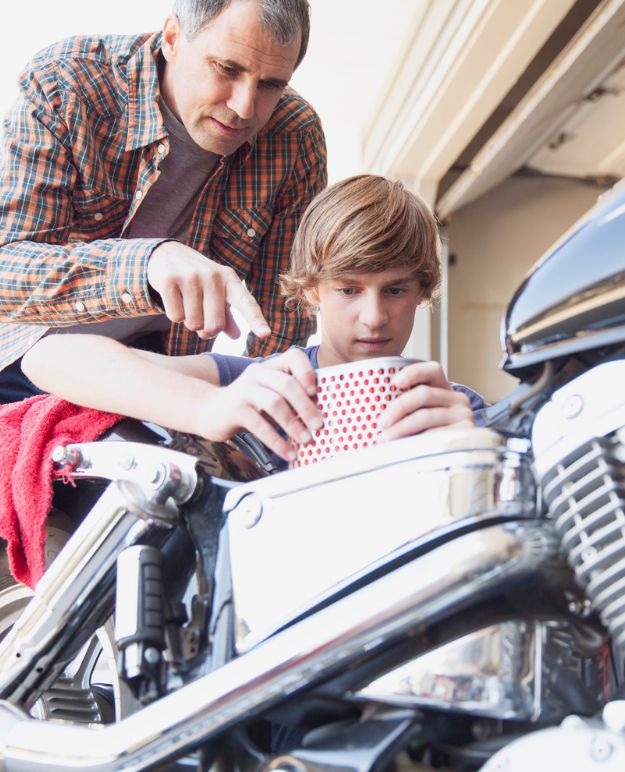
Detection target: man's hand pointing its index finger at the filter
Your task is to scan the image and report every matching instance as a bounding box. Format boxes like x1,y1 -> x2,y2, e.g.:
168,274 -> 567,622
147,241 -> 271,339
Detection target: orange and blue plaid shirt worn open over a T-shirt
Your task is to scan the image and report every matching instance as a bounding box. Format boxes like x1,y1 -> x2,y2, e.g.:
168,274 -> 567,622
0,33 -> 327,369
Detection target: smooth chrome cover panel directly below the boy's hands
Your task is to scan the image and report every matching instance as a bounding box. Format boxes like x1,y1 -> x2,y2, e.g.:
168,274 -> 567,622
225,428 -> 535,652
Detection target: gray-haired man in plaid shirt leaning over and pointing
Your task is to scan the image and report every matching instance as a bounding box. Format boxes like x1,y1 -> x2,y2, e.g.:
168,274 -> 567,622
0,0 -> 326,402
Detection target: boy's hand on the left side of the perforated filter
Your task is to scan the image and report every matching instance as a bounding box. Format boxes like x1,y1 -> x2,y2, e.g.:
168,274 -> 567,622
198,349 -> 323,461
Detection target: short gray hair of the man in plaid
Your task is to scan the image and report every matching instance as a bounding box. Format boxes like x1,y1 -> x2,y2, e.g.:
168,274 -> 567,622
173,0 -> 310,67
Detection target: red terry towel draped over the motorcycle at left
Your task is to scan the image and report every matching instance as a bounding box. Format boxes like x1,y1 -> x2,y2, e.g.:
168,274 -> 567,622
0,394 -> 122,587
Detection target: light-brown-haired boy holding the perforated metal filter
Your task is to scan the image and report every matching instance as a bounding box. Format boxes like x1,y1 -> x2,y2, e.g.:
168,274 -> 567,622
23,175 -> 484,460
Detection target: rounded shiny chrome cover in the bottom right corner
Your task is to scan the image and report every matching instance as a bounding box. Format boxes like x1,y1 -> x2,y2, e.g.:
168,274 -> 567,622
481,703 -> 625,772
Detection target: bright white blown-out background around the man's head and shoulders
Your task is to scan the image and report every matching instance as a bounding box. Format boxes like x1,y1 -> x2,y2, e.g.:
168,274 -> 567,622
0,0 -> 420,181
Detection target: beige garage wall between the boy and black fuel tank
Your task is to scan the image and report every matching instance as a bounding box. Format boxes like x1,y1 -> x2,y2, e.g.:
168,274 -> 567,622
448,177 -> 603,401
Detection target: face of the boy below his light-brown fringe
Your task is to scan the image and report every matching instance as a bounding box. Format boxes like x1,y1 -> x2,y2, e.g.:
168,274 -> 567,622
311,268 -> 421,367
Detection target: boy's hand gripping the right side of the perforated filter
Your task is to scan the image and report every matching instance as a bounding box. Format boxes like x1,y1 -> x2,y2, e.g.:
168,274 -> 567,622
377,362 -> 474,442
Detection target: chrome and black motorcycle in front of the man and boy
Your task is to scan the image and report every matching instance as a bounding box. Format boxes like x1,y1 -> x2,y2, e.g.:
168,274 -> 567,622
0,181 -> 625,772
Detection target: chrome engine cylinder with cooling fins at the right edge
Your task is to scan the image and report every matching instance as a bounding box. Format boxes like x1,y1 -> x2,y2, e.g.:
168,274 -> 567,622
533,360 -> 625,678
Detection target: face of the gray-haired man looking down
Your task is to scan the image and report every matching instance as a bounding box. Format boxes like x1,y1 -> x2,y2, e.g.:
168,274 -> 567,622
161,0 -> 300,155
